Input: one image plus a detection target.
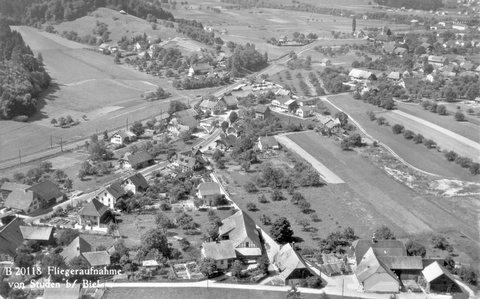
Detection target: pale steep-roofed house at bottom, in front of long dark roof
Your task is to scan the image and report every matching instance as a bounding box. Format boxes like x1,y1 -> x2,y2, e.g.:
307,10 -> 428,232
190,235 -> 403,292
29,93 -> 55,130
354,248 -> 400,293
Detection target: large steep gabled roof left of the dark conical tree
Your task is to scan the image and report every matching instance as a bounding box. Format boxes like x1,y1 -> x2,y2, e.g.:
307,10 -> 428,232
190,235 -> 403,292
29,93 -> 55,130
219,210 -> 262,248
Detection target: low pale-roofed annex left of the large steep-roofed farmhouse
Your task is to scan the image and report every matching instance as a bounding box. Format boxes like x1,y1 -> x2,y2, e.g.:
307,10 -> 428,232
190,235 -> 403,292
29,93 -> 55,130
202,240 -> 237,270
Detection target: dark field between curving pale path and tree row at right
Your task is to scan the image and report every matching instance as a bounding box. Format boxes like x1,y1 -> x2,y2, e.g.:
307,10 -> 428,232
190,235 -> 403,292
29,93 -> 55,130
325,95 -> 477,181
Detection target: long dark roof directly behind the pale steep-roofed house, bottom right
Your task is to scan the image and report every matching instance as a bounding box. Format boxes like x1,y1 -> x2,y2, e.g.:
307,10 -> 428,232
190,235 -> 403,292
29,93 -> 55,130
352,239 -> 407,265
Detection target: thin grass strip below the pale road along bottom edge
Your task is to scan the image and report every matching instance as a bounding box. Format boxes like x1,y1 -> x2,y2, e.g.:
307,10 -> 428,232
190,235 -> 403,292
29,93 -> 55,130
105,287 -> 348,299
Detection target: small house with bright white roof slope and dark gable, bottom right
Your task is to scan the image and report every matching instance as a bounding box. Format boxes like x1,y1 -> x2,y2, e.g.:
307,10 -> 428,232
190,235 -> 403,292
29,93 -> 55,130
420,262 -> 462,294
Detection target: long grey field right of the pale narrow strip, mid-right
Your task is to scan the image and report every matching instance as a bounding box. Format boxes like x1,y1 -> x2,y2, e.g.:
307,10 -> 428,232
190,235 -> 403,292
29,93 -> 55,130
288,132 -> 478,241
